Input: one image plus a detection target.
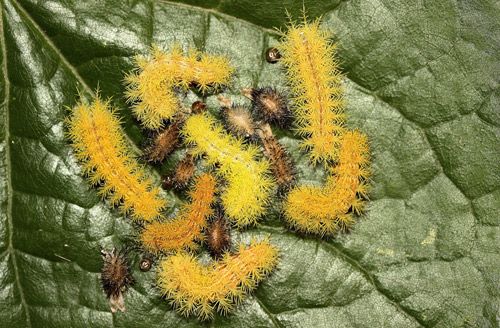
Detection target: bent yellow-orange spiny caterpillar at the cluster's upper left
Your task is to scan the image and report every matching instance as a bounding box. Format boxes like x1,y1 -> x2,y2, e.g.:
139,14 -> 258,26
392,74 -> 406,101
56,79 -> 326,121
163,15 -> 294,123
125,46 -> 234,130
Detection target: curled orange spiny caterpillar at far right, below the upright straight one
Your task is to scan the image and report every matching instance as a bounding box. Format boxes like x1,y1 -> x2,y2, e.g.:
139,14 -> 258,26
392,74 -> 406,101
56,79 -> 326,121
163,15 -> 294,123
283,131 -> 369,235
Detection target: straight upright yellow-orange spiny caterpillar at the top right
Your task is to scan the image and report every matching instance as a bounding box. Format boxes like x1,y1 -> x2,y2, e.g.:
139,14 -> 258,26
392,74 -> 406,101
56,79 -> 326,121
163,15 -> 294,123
279,18 -> 345,163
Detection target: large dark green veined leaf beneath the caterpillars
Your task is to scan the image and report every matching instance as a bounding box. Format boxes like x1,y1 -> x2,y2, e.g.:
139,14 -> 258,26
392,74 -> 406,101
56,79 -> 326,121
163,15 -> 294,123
0,0 -> 500,327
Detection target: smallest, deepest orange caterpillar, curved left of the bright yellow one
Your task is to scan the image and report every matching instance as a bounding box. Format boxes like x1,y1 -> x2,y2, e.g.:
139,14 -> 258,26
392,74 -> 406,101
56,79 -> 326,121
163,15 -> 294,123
140,174 -> 216,253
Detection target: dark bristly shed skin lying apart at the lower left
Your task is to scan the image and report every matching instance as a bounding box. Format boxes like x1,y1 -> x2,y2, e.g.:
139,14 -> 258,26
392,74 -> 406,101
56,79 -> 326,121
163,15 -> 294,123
101,248 -> 134,312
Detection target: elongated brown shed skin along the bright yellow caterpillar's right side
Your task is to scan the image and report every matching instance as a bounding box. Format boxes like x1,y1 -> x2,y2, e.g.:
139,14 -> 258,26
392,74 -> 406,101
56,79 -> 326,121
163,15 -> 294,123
259,124 -> 295,191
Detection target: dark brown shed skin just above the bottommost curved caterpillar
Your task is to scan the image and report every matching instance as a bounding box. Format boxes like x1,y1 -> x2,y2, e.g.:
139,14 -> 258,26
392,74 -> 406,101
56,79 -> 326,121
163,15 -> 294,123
206,210 -> 231,259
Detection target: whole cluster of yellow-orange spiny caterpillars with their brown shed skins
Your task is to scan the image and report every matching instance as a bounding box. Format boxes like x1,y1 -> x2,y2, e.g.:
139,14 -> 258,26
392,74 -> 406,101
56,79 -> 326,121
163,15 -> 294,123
67,20 -> 369,320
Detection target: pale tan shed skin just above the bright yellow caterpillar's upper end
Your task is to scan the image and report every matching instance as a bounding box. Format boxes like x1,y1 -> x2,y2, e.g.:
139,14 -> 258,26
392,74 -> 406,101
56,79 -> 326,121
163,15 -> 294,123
221,104 -> 255,139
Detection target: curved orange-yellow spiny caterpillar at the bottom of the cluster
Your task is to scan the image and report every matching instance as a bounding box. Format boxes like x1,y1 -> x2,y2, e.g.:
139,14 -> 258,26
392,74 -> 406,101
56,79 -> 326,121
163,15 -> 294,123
158,240 -> 278,320
